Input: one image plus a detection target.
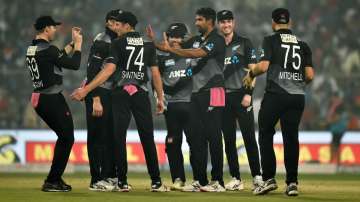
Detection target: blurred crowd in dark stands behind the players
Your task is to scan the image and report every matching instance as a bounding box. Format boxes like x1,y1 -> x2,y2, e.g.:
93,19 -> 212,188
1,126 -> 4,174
0,0 -> 360,130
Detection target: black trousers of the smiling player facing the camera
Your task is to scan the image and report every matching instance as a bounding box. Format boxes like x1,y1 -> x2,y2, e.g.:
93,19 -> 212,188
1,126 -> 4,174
222,91 -> 261,179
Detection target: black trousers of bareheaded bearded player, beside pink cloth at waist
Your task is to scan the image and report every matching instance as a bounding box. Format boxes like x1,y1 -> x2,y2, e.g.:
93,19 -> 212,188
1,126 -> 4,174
189,91 -> 224,186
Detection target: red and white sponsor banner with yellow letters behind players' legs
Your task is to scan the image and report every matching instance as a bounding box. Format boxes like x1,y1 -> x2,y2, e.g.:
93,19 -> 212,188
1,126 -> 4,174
0,130 -> 360,165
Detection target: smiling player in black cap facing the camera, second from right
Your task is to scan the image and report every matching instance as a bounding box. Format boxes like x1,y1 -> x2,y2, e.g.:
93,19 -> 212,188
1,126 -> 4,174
217,10 -> 262,191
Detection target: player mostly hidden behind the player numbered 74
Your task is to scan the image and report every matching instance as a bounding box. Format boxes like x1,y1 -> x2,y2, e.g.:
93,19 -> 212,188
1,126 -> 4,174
85,9 -> 122,191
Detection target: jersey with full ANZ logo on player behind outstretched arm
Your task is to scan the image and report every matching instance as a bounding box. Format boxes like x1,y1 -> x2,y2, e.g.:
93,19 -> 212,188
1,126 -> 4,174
157,51 -> 192,102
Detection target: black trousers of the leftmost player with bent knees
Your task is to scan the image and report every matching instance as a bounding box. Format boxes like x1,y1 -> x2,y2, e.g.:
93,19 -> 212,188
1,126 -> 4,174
35,93 -> 74,182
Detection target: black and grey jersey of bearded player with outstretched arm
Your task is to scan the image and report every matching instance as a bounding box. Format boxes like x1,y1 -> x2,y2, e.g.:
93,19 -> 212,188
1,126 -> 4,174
186,29 -> 225,93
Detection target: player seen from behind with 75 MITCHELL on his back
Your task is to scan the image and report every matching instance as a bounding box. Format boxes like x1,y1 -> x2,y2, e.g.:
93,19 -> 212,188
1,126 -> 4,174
244,8 -> 314,196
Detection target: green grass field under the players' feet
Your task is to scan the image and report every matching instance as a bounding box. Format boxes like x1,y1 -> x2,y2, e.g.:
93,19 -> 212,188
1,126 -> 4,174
0,173 -> 360,202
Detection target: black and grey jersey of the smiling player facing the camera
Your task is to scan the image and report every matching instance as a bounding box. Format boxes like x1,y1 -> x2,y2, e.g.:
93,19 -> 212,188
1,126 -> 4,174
224,32 -> 257,94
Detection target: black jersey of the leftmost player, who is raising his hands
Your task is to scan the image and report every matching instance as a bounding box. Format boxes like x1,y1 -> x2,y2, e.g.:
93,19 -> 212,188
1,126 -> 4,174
26,39 -> 81,94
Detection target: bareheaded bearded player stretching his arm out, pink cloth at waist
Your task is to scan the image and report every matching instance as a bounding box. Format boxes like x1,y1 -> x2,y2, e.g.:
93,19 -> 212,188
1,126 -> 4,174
153,8 -> 225,192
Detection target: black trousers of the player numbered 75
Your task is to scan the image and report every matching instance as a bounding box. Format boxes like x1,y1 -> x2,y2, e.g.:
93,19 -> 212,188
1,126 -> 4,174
259,93 -> 305,184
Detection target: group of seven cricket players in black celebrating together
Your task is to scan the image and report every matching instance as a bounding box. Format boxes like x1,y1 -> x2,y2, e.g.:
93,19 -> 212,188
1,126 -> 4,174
26,8 -> 314,196
